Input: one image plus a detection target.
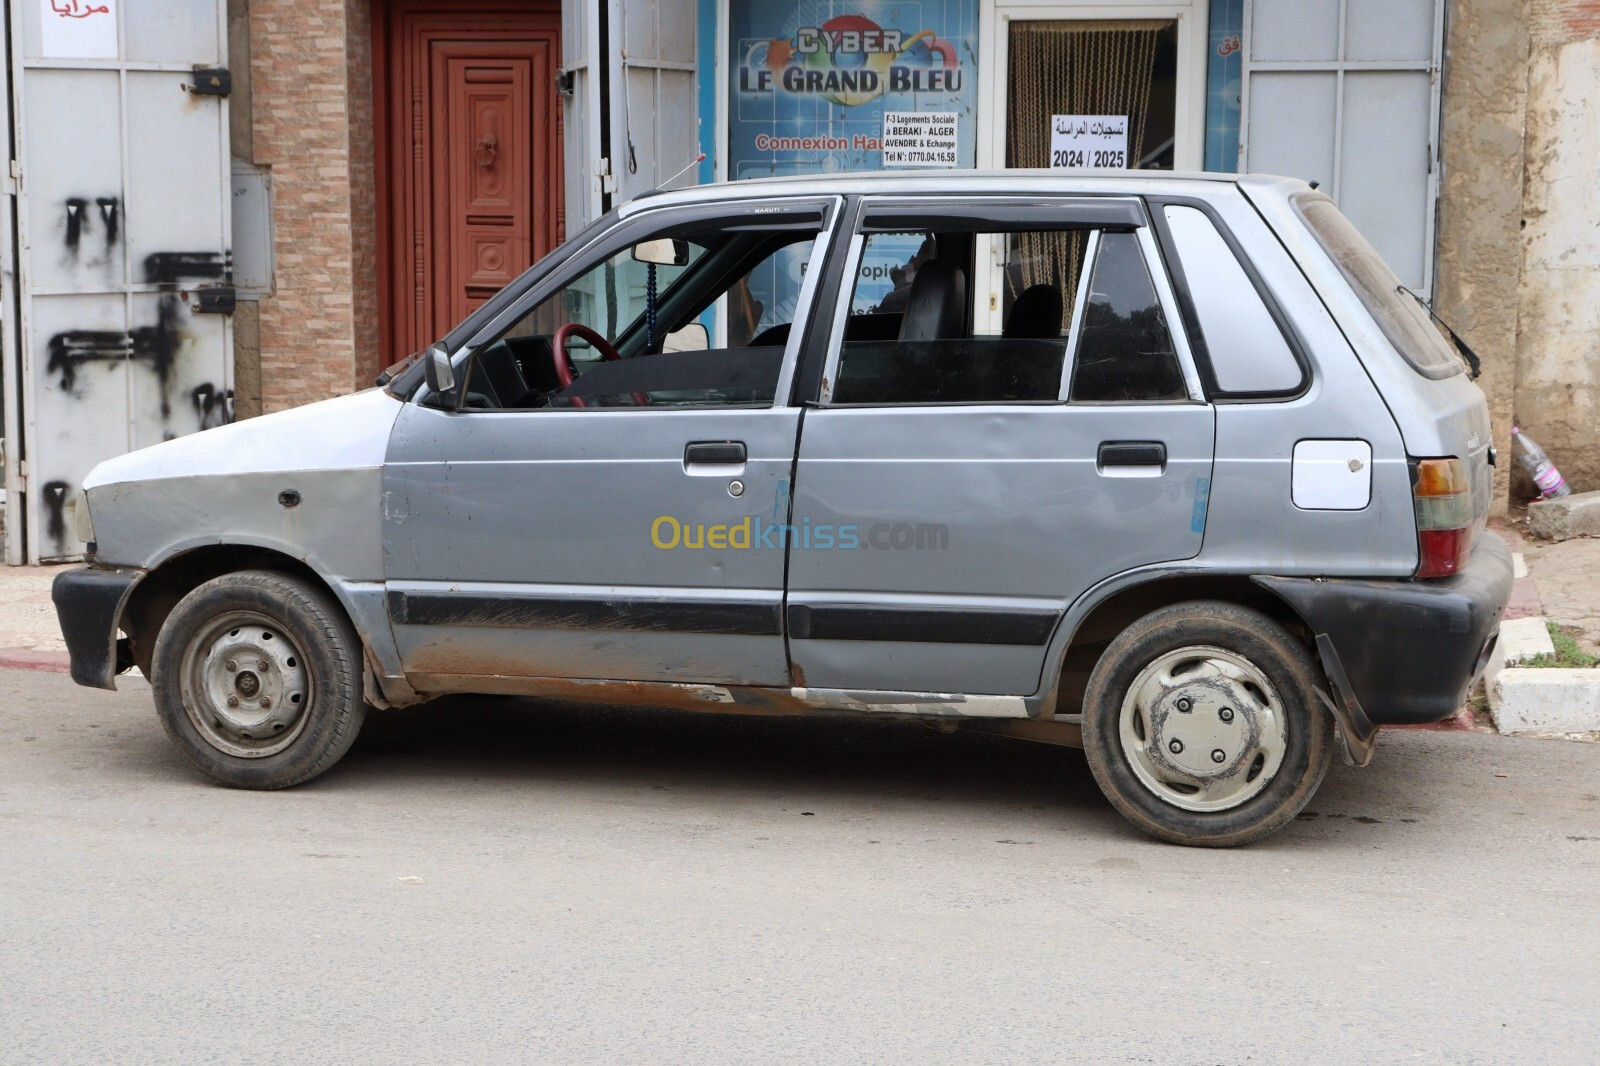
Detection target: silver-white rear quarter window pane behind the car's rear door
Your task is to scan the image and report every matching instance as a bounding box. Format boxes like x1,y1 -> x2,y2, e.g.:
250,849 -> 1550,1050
1163,205 -> 1306,394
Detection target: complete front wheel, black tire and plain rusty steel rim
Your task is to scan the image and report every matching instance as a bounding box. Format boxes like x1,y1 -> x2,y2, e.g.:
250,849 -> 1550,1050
152,570 -> 366,789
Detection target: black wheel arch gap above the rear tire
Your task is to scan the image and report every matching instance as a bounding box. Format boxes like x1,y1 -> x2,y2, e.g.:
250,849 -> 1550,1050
1045,573 -> 1320,714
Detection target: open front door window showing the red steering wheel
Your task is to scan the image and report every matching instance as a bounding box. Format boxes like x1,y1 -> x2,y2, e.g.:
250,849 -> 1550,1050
467,206 -> 824,410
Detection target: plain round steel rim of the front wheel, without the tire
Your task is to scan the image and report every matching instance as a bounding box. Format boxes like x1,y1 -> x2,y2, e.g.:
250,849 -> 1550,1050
179,611 -> 314,759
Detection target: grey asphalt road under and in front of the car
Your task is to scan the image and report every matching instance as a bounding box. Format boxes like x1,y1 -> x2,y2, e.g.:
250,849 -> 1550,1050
0,672 -> 1600,1064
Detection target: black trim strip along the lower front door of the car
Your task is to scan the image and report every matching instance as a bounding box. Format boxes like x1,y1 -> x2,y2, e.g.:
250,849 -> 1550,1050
389,591 -> 782,637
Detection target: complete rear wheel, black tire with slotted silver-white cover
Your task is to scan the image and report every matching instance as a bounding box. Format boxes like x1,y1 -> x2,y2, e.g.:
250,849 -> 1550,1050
1083,602 -> 1334,847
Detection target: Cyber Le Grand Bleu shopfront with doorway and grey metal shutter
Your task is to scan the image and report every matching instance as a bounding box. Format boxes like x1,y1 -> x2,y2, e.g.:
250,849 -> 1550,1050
694,0 -> 1443,291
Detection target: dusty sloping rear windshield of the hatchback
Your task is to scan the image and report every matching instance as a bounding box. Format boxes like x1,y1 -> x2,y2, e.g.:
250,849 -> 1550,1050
1294,192 -> 1464,378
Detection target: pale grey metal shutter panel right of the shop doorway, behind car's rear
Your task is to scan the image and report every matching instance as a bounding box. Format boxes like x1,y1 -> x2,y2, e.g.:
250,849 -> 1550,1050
1240,0 -> 1443,295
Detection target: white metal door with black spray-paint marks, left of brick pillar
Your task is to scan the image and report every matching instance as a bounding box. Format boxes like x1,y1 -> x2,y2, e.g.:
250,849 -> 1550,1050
10,0 -> 234,562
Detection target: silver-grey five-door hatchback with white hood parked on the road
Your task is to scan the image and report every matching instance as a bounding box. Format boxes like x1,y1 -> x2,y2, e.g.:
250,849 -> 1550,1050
54,171 -> 1512,845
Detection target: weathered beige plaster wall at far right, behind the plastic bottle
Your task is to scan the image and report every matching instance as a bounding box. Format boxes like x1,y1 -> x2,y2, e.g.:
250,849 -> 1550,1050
1437,0 -> 1600,509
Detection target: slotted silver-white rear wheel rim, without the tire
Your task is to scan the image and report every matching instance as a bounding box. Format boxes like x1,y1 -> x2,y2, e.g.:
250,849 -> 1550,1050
1117,645 -> 1288,812
